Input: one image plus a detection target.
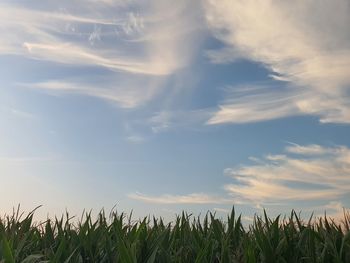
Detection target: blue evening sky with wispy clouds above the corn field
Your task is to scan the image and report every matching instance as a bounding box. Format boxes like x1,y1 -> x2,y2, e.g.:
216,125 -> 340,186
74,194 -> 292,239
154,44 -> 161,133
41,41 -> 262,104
0,0 -> 350,221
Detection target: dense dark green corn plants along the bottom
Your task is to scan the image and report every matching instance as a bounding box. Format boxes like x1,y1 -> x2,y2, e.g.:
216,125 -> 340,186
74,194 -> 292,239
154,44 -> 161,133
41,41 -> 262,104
0,209 -> 350,263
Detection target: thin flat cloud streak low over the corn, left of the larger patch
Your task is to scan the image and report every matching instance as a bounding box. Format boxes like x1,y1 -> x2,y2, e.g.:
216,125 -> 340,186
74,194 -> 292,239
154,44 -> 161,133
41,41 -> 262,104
128,192 -> 232,204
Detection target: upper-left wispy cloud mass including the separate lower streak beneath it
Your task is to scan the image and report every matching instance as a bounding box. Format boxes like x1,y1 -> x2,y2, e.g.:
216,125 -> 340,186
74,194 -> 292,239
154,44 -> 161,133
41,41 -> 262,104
0,0 -> 199,108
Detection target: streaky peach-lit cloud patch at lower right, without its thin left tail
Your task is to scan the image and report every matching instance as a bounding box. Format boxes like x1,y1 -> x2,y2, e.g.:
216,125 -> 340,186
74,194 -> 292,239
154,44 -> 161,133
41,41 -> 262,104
225,145 -> 350,203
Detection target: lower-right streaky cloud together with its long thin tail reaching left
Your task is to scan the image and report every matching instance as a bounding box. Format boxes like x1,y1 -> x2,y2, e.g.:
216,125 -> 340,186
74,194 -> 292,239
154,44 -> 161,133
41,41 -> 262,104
128,143 -> 350,216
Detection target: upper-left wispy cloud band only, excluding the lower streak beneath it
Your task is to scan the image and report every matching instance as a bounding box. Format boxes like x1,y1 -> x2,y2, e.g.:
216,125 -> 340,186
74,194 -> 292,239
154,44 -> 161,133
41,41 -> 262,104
0,1 -> 200,75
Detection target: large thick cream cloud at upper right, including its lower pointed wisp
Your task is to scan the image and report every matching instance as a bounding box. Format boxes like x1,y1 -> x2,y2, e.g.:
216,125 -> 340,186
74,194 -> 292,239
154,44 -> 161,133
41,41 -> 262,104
206,0 -> 350,124
